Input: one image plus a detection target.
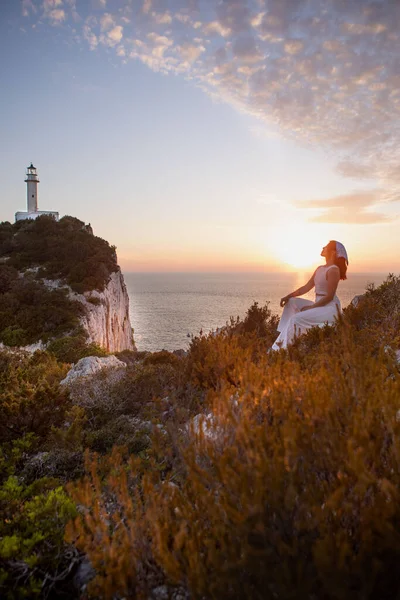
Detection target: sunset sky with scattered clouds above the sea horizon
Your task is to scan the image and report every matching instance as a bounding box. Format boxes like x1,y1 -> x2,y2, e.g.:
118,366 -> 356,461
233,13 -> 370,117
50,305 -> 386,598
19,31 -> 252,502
0,0 -> 400,272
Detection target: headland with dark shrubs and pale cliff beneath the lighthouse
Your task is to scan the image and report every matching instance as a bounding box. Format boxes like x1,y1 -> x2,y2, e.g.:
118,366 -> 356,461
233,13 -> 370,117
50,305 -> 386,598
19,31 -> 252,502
0,216 -> 133,360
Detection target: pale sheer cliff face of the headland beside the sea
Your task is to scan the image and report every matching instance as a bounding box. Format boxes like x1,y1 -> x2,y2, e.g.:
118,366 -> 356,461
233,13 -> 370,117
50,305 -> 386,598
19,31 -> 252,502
69,271 -> 136,352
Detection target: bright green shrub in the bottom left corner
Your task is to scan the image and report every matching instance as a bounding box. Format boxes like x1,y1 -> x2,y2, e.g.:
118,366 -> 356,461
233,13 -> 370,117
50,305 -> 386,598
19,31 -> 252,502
0,434 -> 78,600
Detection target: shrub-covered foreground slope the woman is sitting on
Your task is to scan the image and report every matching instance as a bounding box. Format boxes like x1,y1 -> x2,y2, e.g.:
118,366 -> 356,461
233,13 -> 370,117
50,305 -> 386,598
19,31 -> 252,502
0,276 -> 400,600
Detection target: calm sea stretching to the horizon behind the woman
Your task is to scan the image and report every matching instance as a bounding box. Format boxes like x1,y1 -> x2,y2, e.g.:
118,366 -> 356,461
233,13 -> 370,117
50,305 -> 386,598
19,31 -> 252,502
124,272 -> 387,352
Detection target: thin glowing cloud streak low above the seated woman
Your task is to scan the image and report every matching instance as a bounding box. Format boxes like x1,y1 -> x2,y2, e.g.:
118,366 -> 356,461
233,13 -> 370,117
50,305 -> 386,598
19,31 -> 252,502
296,189 -> 393,225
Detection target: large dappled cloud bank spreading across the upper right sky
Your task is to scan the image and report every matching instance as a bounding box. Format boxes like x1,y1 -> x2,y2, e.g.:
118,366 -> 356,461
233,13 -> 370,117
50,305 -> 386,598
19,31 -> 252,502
22,0 -> 400,222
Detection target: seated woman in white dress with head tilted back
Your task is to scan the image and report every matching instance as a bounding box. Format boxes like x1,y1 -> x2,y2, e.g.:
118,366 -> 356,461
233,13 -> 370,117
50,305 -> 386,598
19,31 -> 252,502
272,241 -> 349,350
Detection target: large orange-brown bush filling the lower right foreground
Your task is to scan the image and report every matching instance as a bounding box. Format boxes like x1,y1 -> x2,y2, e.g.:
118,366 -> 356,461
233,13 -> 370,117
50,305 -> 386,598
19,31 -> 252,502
67,298 -> 400,600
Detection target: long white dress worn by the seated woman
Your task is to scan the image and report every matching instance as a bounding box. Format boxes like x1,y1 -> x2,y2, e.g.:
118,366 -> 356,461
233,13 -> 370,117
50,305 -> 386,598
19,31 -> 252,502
272,265 -> 342,350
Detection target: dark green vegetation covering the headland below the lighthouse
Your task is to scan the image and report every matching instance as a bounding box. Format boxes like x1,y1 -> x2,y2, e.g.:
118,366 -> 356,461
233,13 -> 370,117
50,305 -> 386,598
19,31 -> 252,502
0,215 -> 118,350
